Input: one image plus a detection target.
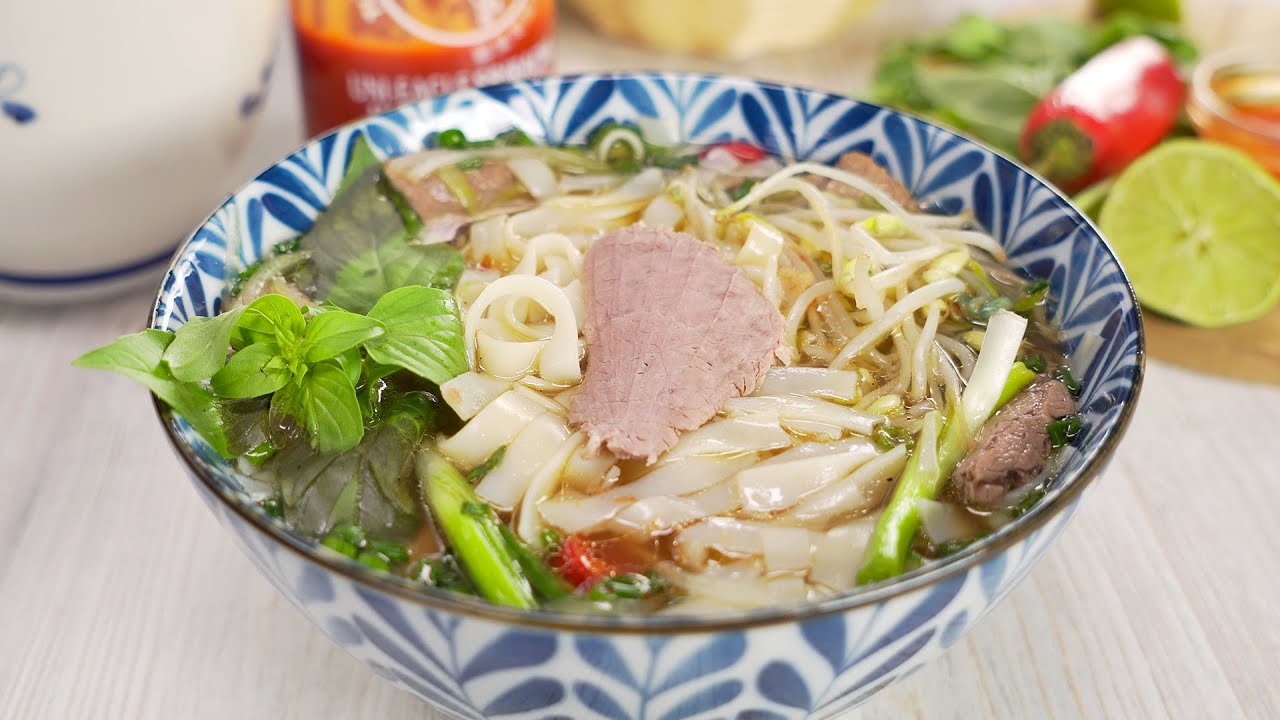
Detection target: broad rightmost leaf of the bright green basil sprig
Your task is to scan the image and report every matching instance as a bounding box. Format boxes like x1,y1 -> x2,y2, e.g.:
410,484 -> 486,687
365,286 -> 467,384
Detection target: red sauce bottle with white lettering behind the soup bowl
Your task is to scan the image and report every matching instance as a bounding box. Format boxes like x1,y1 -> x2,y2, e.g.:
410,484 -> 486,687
291,0 -> 556,136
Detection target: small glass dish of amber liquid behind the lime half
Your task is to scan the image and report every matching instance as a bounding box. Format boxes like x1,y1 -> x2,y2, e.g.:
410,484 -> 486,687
1187,61 -> 1280,177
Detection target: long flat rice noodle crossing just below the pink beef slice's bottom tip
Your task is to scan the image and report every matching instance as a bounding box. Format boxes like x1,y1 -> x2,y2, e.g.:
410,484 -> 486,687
538,455 -> 756,533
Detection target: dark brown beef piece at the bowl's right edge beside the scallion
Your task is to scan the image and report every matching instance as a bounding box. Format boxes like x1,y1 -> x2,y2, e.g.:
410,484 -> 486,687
951,378 -> 1075,507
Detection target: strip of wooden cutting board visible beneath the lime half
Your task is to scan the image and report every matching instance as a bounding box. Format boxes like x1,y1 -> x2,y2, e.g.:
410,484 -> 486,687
1143,301 -> 1280,386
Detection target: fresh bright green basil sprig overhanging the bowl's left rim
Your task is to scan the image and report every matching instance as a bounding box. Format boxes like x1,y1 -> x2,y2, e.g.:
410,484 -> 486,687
74,286 -> 467,457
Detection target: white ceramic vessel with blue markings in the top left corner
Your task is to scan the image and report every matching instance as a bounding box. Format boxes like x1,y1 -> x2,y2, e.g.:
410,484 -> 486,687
0,0 -> 284,302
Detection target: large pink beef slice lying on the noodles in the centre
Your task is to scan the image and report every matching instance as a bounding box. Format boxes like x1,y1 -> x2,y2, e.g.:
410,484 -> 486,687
568,227 -> 783,462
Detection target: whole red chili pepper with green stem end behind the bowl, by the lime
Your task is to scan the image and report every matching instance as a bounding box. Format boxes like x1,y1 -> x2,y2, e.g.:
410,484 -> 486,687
1020,36 -> 1187,192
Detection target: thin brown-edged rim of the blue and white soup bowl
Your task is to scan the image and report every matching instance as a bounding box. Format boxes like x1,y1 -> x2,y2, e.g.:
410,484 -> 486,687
146,70 -> 1147,635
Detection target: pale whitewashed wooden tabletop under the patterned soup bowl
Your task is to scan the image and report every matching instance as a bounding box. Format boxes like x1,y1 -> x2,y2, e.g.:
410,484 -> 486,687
0,7 -> 1280,720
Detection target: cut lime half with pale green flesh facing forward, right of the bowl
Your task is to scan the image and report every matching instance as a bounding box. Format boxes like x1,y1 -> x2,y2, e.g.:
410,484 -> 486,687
1100,140 -> 1280,327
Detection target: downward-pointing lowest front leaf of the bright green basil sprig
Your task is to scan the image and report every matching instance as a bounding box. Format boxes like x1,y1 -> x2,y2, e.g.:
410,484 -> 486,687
291,363 -> 365,452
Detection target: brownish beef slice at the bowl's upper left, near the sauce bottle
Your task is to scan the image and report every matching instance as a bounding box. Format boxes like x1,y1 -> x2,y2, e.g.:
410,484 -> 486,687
384,156 -> 529,220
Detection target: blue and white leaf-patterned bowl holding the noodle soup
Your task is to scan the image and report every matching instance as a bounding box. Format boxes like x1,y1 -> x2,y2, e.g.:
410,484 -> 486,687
152,73 -> 1143,720
